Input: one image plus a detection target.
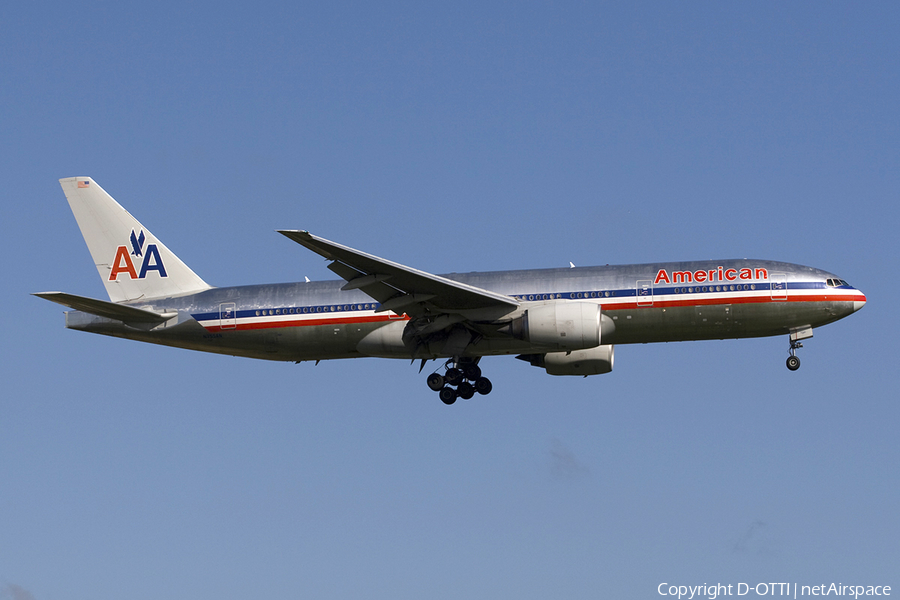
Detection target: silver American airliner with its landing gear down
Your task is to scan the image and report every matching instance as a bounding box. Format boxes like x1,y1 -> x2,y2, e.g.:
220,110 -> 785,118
34,177 -> 866,405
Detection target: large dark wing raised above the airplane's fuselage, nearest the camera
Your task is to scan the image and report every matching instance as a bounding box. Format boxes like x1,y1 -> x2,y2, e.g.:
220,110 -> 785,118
278,230 -> 519,317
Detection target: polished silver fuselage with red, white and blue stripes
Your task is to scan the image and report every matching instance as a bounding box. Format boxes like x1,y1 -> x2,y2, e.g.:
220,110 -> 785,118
66,259 -> 865,361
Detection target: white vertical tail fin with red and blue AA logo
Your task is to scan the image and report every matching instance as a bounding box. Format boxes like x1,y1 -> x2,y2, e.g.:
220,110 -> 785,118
59,177 -> 210,302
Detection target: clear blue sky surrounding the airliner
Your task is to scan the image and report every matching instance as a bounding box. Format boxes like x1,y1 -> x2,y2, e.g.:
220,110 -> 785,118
0,2 -> 900,600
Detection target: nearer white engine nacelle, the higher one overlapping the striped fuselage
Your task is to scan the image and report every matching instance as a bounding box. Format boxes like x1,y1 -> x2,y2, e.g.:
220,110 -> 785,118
511,302 -> 600,351
